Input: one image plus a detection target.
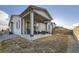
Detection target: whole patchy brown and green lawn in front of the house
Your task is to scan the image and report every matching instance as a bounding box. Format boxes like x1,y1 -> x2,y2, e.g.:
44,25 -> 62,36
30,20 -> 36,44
0,34 -> 70,53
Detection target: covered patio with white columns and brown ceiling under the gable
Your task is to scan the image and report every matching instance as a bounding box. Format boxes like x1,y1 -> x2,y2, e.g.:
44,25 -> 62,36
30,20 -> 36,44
21,5 -> 52,36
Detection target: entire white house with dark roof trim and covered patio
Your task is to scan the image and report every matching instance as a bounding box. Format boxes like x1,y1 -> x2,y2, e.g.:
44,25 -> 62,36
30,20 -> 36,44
9,5 -> 53,38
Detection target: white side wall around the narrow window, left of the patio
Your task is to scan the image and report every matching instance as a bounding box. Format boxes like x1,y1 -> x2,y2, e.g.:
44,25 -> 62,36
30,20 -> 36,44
12,16 -> 21,35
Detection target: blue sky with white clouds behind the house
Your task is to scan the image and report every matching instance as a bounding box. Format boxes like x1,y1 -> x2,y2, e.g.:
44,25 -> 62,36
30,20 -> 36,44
0,5 -> 79,28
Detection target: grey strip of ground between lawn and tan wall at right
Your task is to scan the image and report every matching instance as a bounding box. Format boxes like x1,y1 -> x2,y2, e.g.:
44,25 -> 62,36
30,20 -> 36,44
67,35 -> 79,53
